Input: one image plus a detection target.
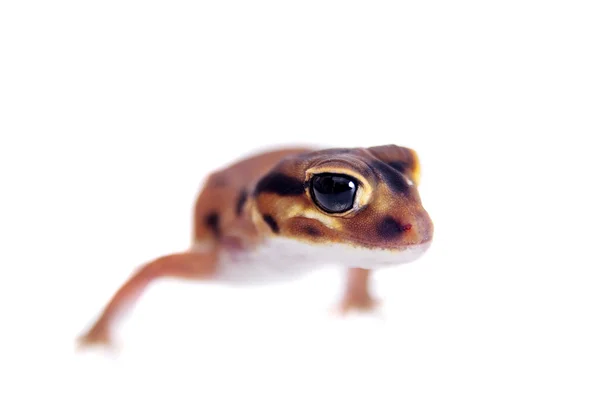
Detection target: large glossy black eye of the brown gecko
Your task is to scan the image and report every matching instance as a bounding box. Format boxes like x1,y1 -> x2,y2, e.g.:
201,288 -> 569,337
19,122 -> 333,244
310,174 -> 357,213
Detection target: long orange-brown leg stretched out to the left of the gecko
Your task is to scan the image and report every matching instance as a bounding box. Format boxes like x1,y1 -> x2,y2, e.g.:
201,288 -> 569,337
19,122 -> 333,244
78,251 -> 217,348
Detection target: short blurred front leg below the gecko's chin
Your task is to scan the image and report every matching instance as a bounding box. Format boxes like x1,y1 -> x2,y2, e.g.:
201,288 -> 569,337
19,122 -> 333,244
338,268 -> 380,314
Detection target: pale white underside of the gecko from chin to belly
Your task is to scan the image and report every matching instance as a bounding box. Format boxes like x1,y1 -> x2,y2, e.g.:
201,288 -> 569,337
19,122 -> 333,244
209,238 -> 429,284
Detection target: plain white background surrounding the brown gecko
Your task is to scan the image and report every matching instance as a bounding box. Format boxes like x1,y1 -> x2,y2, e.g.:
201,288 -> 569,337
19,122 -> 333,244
0,0 -> 600,399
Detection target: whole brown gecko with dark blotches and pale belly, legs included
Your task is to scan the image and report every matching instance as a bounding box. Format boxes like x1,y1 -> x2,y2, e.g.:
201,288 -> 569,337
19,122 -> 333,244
77,144 -> 433,348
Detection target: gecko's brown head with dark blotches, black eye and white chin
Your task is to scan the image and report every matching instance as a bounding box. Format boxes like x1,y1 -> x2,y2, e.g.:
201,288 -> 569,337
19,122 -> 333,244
253,145 -> 433,268
